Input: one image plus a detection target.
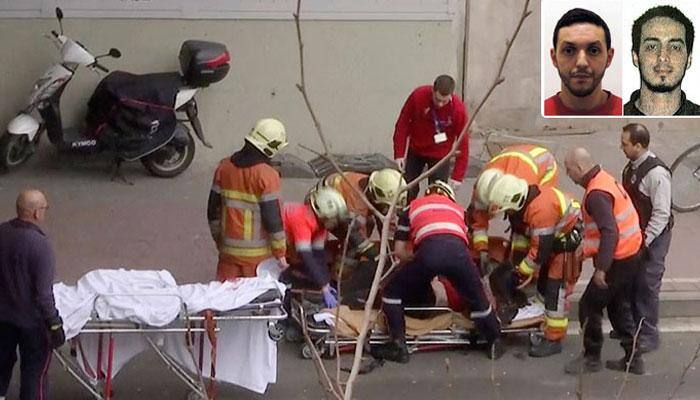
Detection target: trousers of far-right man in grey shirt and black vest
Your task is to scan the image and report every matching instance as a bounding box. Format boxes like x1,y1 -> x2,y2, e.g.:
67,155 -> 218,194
625,229 -> 671,349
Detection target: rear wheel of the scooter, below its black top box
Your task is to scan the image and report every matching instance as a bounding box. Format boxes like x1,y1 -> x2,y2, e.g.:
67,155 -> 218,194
141,134 -> 195,178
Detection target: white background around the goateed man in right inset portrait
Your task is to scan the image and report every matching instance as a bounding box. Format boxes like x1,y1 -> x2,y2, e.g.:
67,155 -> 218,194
619,0 -> 700,108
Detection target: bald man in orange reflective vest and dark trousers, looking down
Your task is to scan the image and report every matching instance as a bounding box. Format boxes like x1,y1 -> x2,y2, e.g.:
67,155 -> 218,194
564,148 -> 644,374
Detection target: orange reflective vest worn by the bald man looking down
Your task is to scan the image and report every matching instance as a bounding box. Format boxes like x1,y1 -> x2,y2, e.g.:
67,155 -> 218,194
583,169 -> 642,260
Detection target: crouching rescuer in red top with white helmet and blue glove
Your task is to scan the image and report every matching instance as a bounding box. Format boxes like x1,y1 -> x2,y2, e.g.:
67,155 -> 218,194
280,188 -> 348,308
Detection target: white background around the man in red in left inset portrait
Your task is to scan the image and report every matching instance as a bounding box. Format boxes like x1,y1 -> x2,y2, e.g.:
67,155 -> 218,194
540,0 -> 625,115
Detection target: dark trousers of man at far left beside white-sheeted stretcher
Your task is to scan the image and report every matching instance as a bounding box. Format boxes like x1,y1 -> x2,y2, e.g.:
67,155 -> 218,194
0,322 -> 51,400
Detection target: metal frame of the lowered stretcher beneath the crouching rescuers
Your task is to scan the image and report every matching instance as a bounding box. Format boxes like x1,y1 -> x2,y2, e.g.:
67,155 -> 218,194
290,290 -> 544,359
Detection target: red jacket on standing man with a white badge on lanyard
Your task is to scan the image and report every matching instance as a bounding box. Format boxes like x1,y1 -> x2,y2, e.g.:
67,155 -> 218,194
394,85 -> 469,181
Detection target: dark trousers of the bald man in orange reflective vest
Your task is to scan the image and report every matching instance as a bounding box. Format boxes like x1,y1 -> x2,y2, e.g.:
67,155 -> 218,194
578,255 -> 640,357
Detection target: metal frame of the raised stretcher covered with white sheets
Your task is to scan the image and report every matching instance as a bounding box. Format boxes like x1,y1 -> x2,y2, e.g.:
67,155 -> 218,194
53,293 -> 288,400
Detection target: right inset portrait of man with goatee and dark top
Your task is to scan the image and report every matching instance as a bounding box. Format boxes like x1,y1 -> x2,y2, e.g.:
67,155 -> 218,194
623,0 -> 700,117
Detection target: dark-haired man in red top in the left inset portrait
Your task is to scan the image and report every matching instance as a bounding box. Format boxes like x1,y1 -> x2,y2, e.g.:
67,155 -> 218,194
544,8 -> 622,116
